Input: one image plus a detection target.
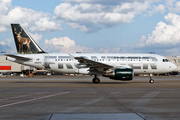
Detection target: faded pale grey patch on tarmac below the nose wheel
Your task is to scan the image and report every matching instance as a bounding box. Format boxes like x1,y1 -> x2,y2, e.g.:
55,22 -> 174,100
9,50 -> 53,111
133,91 -> 160,106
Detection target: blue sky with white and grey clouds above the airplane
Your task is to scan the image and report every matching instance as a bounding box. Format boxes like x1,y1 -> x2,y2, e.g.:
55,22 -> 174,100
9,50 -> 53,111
0,0 -> 180,56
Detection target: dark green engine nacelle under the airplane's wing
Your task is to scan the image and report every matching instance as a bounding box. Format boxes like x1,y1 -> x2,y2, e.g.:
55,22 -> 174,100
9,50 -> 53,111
103,68 -> 134,81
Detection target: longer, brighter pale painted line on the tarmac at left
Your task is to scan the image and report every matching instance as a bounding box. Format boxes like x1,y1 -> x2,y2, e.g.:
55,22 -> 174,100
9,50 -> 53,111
0,92 -> 69,108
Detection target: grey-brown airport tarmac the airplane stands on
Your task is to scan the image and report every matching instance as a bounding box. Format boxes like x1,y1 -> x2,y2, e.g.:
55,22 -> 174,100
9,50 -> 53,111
0,75 -> 180,120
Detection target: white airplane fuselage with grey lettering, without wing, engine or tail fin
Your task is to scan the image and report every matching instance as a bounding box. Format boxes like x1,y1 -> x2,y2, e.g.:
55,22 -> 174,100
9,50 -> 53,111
7,53 -> 176,74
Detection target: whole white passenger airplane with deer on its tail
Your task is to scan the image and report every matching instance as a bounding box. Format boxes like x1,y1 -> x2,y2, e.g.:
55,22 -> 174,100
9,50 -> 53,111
5,24 -> 177,83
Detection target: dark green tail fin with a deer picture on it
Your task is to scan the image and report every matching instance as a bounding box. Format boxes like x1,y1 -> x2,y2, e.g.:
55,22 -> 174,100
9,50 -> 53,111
11,24 -> 46,54
